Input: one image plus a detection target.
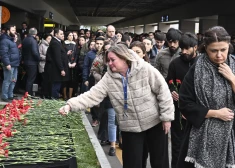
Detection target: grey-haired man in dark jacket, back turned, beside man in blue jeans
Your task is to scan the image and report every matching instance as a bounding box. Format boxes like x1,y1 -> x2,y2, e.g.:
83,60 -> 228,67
22,28 -> 40,95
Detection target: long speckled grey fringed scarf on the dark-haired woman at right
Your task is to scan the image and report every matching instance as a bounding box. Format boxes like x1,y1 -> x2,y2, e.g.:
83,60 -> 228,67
185,54 -> 235,168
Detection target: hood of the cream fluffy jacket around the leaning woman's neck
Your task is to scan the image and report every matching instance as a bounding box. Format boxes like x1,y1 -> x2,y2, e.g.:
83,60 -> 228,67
107,49 -> 145,78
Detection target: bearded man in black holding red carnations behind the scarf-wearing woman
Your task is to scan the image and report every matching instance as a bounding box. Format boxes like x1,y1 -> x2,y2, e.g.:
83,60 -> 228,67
166,32 -> 198,168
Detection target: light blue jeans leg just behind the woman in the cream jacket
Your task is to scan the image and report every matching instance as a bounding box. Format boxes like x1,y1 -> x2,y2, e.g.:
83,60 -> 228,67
108,108 -> 117,142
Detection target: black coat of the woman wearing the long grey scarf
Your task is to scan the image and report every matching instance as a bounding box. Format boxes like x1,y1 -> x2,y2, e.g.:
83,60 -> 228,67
176,64 -> 209,168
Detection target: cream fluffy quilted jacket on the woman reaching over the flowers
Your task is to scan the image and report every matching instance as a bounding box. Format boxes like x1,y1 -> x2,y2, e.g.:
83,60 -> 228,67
67,51 -> 174,132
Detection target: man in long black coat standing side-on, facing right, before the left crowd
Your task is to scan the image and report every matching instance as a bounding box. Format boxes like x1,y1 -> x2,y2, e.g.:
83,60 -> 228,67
45,28 -> 69,99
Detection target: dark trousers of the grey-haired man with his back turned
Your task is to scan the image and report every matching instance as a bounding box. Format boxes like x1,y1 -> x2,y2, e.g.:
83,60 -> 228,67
25,65 -> 38,95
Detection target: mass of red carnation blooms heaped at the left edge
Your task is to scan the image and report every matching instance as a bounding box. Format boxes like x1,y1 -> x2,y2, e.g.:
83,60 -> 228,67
0,92 -> 38,157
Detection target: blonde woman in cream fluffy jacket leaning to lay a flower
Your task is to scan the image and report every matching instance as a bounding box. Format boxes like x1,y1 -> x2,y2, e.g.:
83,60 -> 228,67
59,44 -> 174,168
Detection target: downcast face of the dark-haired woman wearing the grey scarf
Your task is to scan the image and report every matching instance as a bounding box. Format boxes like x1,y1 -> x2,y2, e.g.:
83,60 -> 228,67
206,41 -> 229,64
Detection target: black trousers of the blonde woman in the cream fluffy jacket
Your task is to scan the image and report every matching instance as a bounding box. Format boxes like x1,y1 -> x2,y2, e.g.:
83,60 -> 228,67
122,123 -> 169,168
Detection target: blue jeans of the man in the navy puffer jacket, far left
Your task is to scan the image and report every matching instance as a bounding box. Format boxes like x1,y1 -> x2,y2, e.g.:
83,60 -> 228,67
2,67 -> 18,99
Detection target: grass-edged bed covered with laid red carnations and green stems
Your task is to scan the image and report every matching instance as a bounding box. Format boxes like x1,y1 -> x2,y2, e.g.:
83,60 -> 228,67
0,92 -> 97,168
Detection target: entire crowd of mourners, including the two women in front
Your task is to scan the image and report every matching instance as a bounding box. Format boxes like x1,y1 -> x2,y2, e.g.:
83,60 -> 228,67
0,20 -> 235,168
